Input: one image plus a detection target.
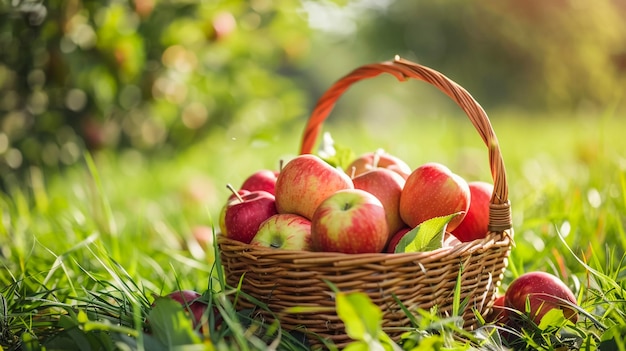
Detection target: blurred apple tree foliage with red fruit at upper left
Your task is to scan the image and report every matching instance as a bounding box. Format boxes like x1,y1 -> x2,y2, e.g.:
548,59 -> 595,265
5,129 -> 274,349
0,0 -> 308,184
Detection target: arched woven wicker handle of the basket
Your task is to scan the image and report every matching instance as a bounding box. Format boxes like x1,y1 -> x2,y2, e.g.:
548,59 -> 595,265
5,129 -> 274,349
300,56 -> 512,232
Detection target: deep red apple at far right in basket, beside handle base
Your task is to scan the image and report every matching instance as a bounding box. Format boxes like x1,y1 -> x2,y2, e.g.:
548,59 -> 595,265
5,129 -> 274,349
452,181 -> 493,242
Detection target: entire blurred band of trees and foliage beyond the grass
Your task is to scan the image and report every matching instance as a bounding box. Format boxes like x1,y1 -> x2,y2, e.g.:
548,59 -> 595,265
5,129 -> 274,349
0,0 -> 626,187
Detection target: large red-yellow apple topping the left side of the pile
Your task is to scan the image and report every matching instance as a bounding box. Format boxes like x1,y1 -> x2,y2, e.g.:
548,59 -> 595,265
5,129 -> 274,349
276,154 -> 354,220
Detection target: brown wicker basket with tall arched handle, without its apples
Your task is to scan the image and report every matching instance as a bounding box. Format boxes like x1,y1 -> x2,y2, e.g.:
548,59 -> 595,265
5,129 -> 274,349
218,57 -> 513,347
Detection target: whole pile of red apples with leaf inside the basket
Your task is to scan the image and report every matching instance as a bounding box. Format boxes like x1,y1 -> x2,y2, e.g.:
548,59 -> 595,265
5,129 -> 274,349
220,150 -> 493,254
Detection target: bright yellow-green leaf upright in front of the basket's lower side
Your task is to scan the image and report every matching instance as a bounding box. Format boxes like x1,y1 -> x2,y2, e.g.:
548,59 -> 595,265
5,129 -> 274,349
337,292 -> 383,342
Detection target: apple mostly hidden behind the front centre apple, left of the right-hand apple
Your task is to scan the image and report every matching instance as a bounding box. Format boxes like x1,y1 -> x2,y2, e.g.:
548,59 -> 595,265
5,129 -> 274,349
352,168 -> 406,239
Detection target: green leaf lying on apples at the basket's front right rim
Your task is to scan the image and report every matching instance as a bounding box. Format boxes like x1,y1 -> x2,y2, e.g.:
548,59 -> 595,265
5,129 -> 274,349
395,212 -> 463,253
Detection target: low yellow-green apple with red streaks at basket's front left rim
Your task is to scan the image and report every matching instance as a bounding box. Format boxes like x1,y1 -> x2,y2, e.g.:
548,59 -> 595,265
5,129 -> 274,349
250,213 -> 311,251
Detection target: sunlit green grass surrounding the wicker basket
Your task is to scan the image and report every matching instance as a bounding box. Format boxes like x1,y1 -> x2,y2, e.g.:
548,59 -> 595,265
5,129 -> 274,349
0,113 -> 626,350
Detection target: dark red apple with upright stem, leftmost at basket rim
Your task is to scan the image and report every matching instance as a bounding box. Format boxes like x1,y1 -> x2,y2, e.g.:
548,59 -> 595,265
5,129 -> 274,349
222,190 -> 277,244
